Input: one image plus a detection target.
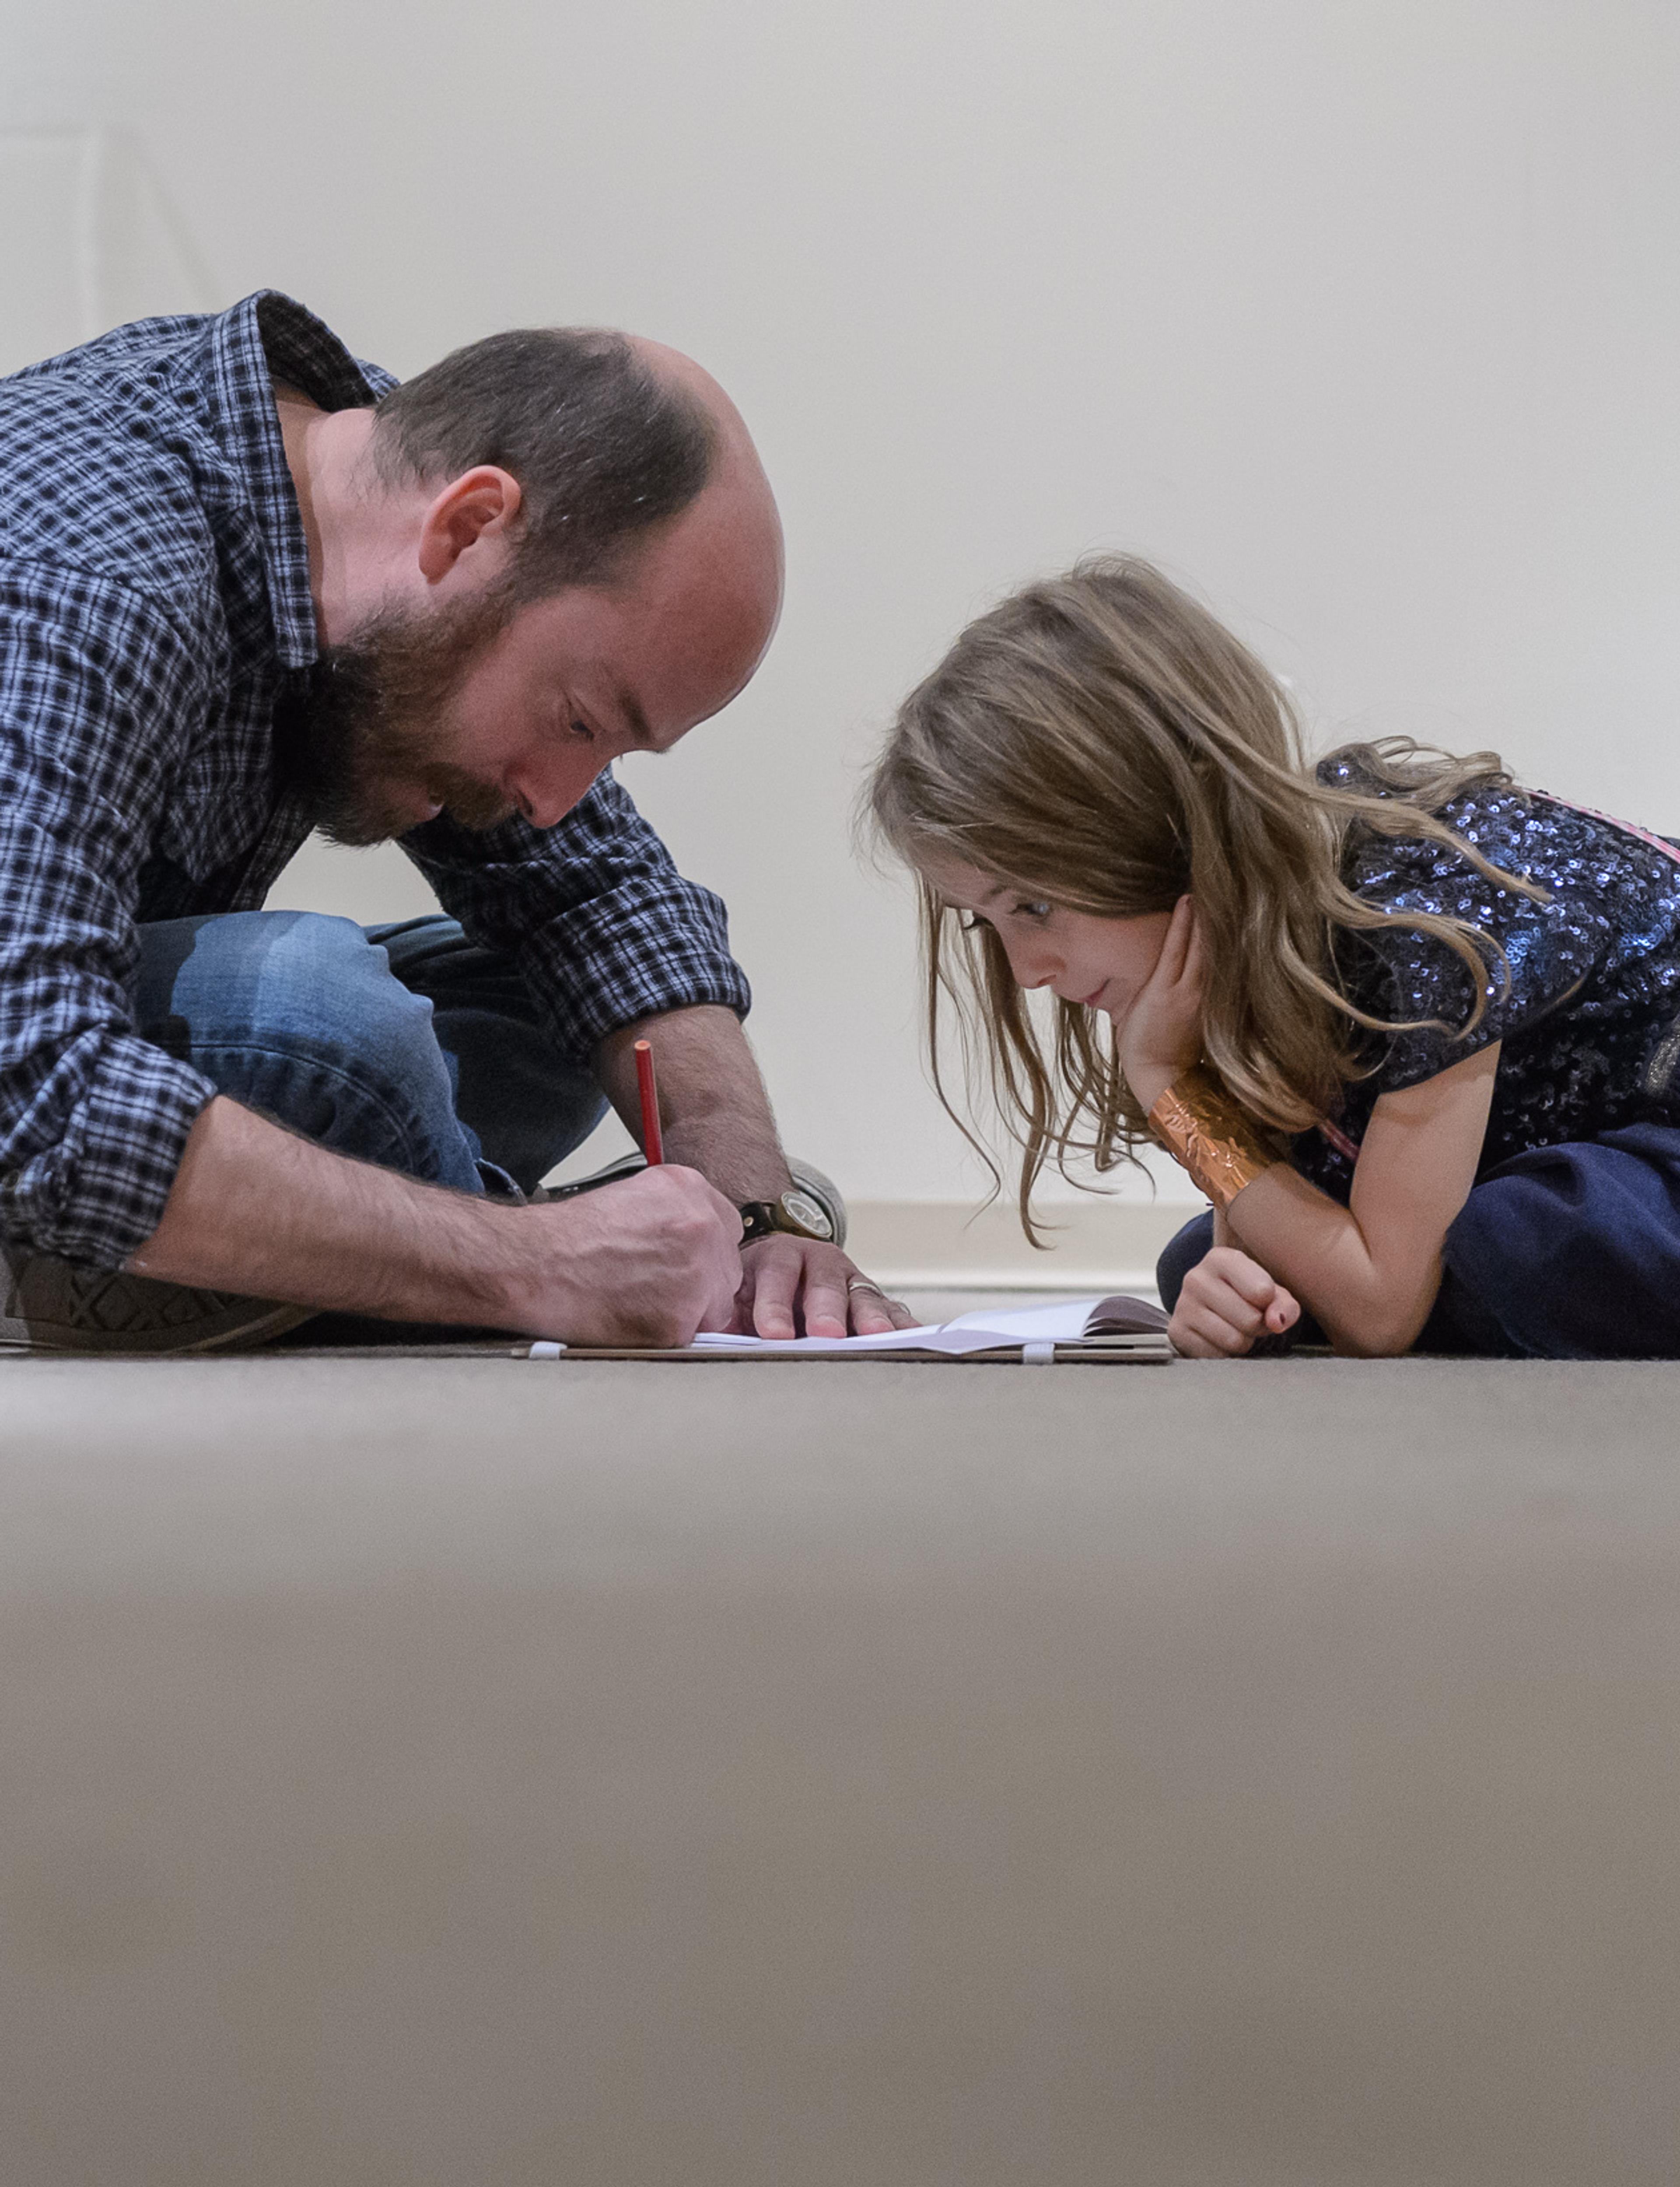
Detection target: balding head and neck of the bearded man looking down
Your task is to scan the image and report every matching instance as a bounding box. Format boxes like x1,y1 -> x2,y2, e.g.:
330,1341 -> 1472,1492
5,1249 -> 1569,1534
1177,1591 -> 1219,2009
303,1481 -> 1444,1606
280,328 -> 781,842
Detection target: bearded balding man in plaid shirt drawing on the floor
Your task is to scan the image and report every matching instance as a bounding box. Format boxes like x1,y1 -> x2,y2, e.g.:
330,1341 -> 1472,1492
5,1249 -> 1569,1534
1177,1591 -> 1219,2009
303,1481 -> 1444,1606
0,293 -> 901,1349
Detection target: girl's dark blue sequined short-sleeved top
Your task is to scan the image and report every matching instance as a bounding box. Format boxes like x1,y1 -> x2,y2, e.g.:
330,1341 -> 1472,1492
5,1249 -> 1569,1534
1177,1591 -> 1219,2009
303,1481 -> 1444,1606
1291,752 -> 1680,1201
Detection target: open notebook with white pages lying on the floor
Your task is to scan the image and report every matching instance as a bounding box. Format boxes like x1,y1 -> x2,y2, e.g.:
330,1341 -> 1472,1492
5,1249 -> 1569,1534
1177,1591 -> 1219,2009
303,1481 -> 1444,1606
529,1297 -> 1172,1367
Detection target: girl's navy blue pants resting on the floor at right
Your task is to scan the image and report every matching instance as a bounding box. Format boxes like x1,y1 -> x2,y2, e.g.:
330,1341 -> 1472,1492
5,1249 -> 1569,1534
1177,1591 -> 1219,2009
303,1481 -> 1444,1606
1155,1124 -> 1680,1360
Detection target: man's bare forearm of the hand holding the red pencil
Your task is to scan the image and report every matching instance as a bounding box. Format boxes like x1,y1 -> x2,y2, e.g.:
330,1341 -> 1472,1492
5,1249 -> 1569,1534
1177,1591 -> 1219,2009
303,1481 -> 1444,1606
129,1096 -> 527,1325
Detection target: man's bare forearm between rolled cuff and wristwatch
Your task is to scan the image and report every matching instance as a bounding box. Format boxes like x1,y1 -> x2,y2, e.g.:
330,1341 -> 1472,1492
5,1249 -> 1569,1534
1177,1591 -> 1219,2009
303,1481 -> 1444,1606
595,1004 -> 792,1205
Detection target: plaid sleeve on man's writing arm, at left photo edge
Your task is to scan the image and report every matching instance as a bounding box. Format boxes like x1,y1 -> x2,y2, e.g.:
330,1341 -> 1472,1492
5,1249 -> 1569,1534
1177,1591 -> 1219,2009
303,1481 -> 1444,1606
0,564 -> 214,1269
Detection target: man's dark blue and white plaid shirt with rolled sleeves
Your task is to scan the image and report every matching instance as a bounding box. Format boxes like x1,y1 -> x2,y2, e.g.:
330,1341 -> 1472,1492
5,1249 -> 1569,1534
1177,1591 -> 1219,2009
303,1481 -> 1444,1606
0,293 -> 748,1266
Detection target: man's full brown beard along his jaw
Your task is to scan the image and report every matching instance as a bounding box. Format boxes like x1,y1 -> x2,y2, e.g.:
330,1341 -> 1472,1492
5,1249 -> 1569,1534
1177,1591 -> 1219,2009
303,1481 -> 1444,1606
287,595 -> 514,848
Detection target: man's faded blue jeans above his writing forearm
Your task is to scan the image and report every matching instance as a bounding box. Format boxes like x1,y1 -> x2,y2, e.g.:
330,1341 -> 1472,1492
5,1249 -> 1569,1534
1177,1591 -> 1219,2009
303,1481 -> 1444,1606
133,912 -> 606,1192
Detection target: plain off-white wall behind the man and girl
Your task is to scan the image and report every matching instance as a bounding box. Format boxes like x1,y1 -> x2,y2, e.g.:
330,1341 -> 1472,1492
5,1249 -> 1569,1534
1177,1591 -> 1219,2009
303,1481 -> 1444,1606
0,0 -> 1680,1199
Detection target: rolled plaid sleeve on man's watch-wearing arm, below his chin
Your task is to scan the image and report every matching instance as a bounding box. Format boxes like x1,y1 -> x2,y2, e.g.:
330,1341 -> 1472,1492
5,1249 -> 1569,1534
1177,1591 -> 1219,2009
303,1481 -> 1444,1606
402,774 -> 752,1056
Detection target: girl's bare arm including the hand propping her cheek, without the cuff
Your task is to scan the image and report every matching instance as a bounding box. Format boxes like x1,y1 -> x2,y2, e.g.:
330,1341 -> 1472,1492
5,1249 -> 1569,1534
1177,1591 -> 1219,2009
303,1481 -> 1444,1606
1118,899 -> 1498,1354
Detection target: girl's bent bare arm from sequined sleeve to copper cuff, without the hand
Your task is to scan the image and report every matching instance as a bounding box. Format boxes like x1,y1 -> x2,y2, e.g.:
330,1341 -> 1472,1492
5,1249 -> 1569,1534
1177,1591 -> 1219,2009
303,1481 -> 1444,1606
1227,1043 -> 1498,1356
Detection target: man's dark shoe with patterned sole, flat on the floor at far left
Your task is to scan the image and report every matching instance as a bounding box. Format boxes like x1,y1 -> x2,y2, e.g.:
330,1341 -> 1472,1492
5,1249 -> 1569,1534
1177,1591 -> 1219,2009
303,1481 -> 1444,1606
0,1244 -> 311,1354
